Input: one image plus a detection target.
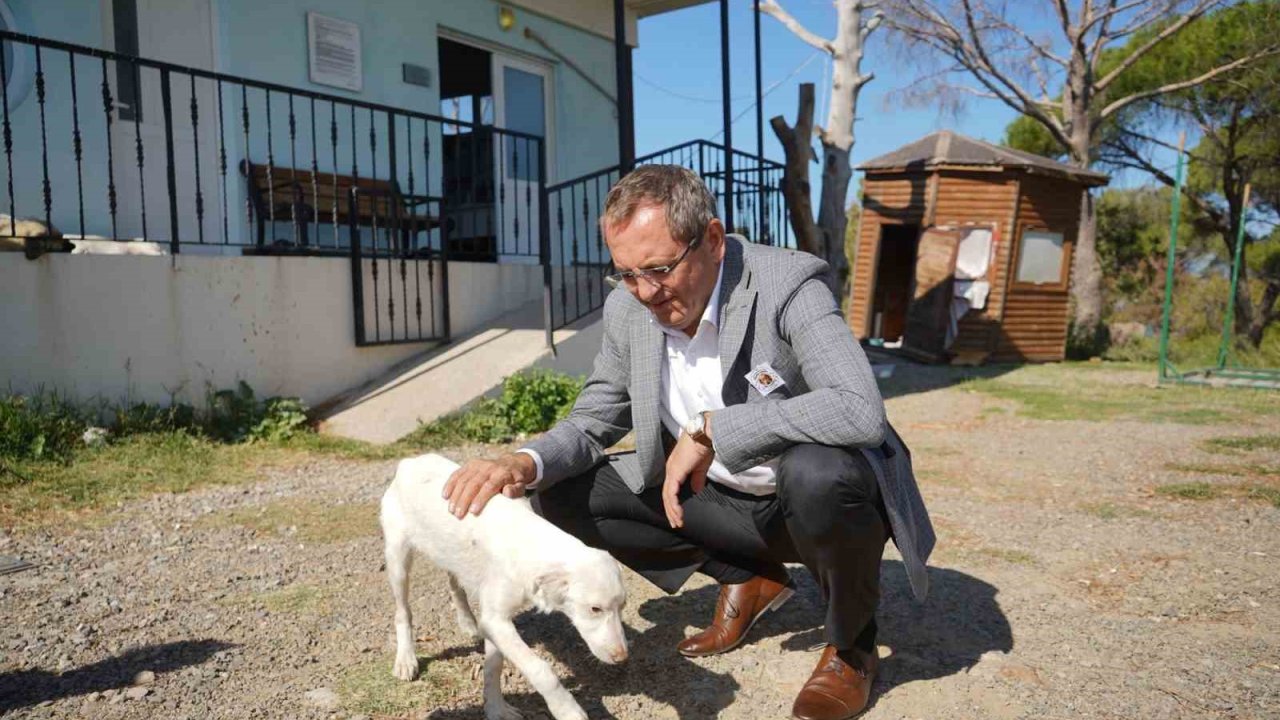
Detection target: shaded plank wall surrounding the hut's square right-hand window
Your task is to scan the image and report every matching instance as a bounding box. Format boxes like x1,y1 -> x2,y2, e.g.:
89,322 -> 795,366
992,176 -> 1083,361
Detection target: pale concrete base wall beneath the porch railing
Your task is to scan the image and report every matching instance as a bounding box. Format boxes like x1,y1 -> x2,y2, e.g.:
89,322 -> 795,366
0,254 -> 541,405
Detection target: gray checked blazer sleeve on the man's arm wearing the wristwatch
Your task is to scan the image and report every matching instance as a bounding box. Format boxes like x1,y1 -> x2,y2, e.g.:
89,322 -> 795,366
712,263 -> 886,473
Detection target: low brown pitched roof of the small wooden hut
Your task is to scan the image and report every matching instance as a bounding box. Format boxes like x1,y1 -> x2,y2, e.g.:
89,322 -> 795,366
858,131 -> 1111,186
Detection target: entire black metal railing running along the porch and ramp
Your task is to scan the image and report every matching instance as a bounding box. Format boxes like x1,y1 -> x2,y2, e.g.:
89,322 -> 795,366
0,31 -> 794,345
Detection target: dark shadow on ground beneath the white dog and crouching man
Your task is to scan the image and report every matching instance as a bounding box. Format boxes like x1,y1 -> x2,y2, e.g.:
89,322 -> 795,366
419,560 -> 1014,720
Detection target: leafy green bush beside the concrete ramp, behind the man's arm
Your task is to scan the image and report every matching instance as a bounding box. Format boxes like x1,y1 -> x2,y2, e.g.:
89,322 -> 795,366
406,370 -> 582,447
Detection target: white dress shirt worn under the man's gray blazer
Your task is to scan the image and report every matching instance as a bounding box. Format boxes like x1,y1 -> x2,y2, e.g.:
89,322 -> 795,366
518,261 -> 777,495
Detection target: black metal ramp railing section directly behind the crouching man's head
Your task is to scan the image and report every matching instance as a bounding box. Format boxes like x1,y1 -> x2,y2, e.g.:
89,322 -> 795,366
545,140 -> 795,329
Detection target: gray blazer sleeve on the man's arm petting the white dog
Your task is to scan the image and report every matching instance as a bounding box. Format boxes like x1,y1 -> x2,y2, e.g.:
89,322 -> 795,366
525,292 -> 631,489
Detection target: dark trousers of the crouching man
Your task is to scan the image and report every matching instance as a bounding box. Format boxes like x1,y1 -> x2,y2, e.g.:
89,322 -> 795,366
534,445 -> 888,651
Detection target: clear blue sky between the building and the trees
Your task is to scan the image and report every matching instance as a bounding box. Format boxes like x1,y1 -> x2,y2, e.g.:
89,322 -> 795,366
634,0 -> 1172,196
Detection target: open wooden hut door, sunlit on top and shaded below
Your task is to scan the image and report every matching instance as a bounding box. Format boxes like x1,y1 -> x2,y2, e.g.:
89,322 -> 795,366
902,228 -> 960,360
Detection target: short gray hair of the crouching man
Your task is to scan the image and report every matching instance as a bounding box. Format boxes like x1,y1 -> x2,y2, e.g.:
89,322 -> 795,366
600,165 -> 716,243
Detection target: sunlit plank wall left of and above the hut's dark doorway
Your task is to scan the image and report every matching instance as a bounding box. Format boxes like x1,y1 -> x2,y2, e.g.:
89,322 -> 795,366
849,173 -> 932,340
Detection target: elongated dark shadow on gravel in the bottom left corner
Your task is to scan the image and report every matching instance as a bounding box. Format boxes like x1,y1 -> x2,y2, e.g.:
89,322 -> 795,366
0,639 -> 236,712
